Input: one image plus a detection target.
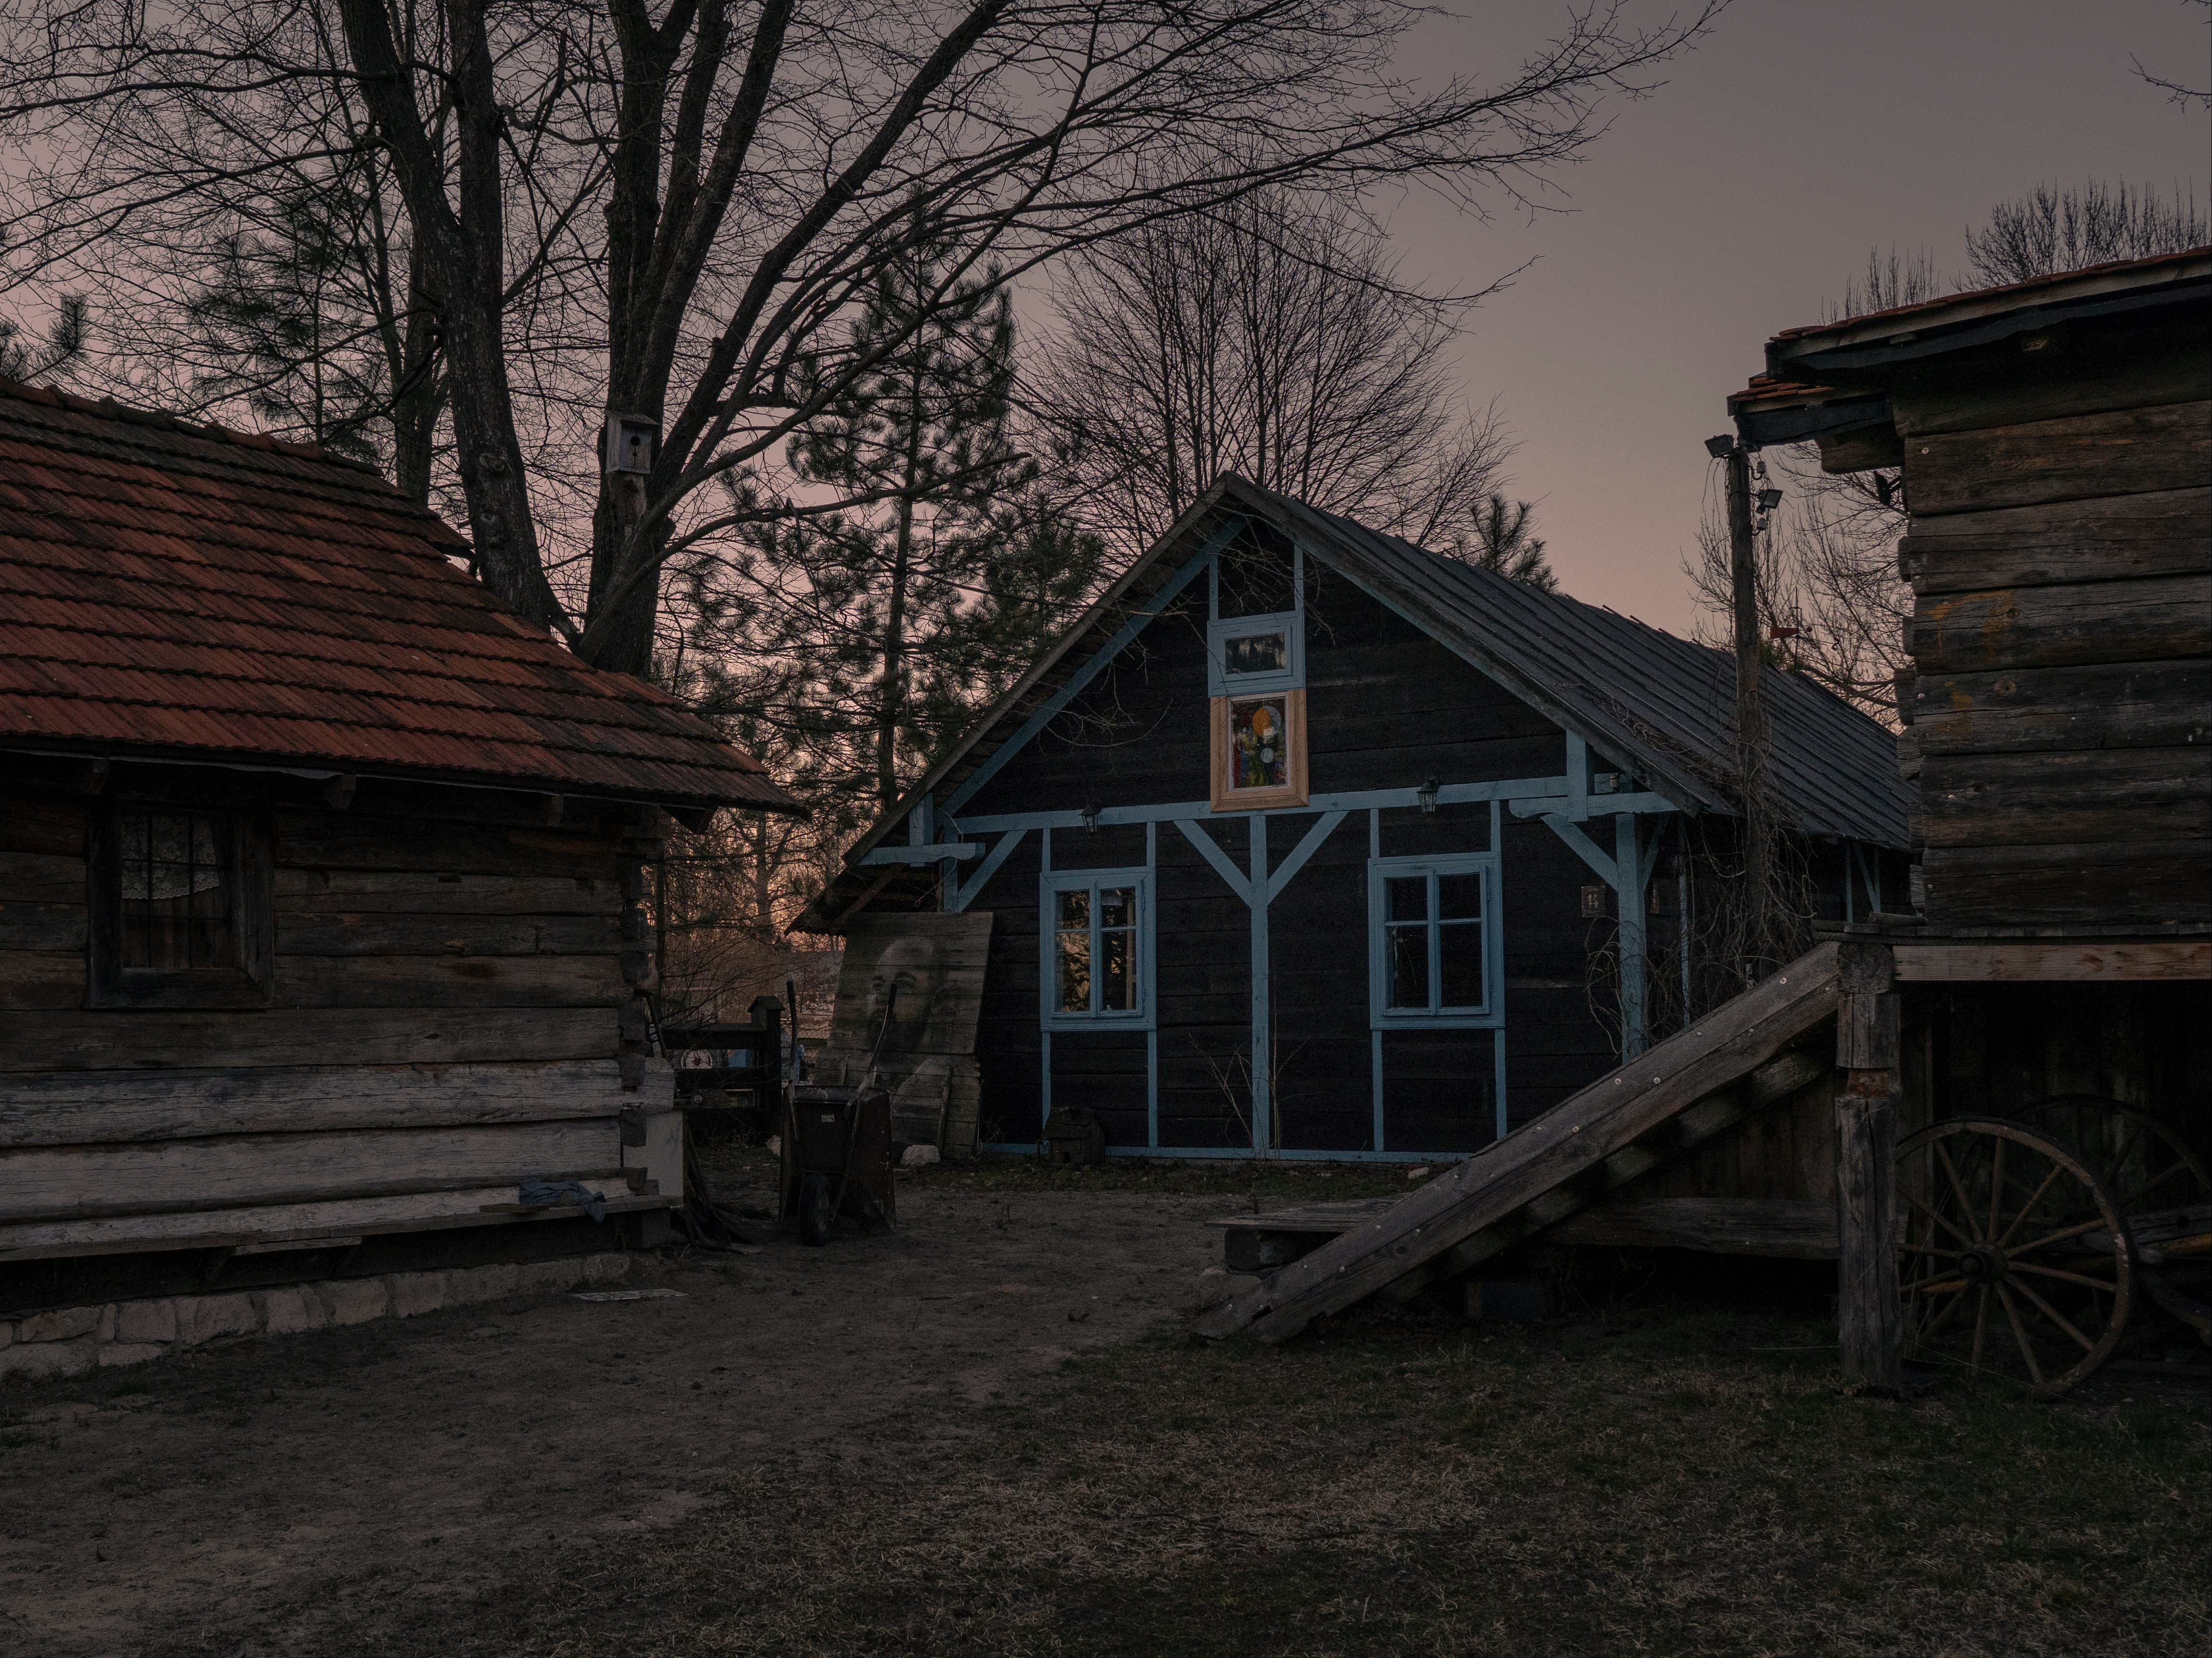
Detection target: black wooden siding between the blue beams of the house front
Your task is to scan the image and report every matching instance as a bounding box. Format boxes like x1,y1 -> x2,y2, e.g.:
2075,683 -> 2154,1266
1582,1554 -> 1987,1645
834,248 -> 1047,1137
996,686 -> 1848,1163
962,566 -> 1666,1152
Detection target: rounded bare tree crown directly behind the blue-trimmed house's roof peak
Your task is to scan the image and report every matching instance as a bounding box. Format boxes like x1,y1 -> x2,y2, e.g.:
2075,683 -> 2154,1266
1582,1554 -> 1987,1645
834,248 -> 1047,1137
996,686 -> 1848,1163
1031,188 -> 1508,555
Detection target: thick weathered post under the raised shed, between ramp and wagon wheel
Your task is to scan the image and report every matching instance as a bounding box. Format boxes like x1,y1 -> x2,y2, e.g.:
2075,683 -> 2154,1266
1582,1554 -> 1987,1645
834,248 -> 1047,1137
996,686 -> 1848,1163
1836,942 -> 1905,1393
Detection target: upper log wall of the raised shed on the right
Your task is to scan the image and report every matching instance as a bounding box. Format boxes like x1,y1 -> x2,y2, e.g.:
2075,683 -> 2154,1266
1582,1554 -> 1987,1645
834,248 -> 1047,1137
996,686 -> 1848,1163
1891,329 -> 2212,929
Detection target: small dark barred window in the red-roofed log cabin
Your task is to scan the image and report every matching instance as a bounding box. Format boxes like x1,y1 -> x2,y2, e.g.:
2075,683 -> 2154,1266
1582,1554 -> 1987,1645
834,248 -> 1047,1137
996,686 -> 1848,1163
86,800 -> 274,1008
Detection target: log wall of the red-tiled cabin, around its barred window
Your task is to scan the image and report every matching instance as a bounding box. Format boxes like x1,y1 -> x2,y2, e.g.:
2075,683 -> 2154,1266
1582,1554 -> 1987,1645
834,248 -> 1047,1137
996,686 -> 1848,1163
0,791 -> 668,1254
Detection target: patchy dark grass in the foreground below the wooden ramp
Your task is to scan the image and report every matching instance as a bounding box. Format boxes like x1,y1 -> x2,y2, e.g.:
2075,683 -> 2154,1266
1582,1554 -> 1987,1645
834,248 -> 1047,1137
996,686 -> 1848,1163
272,1298 -> 2212,1658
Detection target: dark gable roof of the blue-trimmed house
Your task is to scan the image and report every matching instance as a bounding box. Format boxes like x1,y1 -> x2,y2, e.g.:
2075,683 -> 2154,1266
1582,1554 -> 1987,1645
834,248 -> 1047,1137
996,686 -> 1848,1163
801,477 -> 1916,929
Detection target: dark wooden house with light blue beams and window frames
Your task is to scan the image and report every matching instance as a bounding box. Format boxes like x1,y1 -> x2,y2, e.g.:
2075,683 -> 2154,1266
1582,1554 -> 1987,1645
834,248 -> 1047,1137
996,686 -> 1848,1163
801,480 -> 1911,1161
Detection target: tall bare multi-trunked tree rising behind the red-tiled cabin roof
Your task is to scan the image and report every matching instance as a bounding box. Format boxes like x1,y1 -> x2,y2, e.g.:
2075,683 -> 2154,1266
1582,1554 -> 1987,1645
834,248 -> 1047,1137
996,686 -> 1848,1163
0,0 -> 1719,670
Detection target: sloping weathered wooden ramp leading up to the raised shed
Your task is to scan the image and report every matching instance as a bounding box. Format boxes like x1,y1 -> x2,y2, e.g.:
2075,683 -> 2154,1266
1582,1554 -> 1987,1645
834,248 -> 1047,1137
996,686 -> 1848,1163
1197,944 -> 1840,1342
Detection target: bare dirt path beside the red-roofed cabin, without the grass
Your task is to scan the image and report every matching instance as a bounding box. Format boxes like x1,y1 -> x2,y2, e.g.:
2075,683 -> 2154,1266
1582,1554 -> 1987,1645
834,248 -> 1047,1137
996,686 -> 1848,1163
0,1183 -> 1223,1658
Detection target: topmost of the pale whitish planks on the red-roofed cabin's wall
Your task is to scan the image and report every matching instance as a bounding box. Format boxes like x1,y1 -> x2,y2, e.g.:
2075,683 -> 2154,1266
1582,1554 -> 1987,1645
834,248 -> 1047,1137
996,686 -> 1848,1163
0,1059 -> 675,1147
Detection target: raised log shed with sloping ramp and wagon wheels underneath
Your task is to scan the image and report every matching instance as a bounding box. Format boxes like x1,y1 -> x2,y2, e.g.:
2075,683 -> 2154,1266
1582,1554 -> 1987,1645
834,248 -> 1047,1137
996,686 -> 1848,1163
1208,248 -> 2212,1388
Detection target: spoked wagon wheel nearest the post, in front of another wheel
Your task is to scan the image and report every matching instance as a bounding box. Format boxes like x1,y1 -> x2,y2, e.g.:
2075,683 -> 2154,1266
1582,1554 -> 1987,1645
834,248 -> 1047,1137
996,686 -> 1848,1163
1898,1117 -> 2135,1393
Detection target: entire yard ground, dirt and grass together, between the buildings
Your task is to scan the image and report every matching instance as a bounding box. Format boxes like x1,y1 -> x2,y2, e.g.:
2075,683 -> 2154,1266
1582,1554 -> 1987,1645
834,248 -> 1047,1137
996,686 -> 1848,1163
0,1152 -> 2212,1658
